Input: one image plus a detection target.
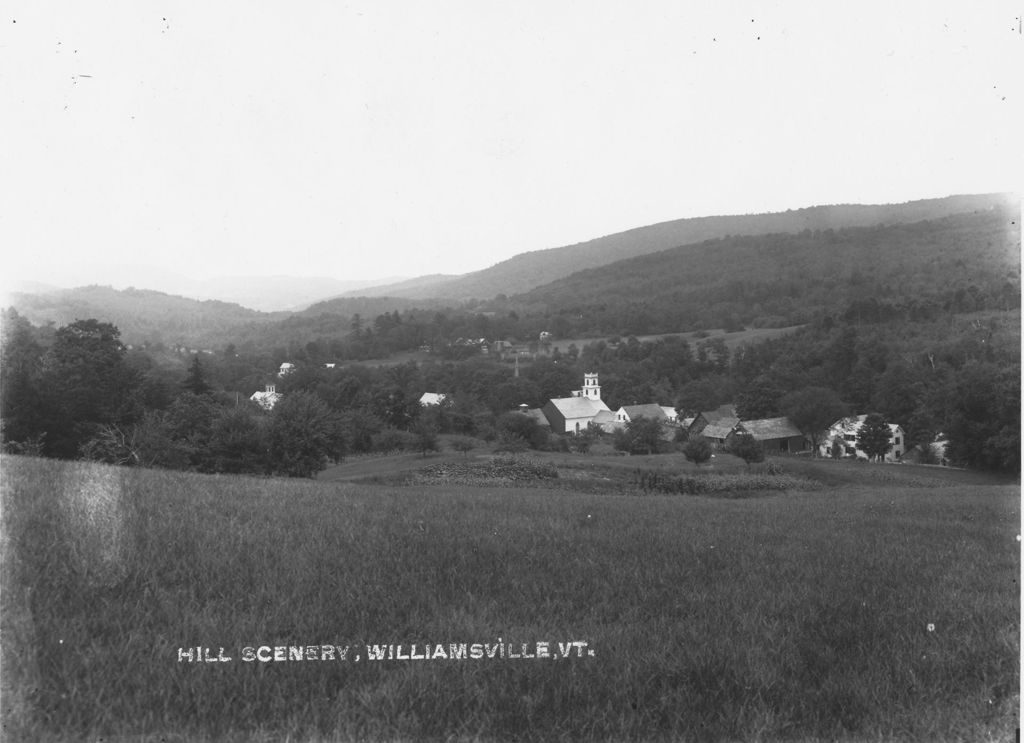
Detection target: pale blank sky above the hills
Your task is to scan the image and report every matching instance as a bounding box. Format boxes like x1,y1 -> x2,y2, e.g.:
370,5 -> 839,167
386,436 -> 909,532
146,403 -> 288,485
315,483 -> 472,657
0,0 -> 1024,285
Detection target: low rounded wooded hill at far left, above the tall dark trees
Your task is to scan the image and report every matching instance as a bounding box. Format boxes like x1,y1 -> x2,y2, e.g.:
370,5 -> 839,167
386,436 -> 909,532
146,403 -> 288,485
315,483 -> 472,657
10,287 -> 280,346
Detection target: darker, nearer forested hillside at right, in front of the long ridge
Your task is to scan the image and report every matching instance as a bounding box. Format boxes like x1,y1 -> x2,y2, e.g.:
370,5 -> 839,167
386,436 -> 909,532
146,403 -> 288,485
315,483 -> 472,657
513,204 -> 1021,335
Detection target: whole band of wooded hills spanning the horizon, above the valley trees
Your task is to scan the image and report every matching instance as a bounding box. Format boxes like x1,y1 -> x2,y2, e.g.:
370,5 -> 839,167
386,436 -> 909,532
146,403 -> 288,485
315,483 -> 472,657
4,193 -> 1020,348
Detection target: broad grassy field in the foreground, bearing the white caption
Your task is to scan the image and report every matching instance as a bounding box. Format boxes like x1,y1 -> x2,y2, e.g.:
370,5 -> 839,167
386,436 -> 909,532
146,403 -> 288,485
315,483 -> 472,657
0,456 -> 1021,741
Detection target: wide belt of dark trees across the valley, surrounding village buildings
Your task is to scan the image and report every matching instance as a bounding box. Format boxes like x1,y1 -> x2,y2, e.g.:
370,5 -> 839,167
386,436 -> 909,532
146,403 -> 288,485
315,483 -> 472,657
6,292 -> 1020,475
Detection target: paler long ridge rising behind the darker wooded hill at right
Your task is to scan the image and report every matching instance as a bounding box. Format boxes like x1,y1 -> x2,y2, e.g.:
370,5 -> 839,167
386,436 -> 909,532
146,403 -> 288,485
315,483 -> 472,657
352,193 -> 1015,300
